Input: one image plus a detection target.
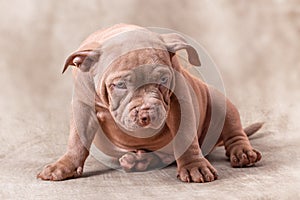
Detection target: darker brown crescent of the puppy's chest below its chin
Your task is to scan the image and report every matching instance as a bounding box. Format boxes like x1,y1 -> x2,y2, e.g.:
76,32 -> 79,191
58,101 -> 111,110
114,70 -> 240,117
97,111 -> 172,151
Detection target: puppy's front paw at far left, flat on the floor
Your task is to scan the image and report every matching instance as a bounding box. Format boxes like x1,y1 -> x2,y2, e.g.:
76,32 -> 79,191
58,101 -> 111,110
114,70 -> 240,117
37,157 -> 83,181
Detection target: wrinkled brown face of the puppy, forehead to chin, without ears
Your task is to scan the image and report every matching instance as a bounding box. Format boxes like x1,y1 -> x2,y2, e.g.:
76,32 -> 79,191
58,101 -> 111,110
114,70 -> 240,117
105,49 -> 174,132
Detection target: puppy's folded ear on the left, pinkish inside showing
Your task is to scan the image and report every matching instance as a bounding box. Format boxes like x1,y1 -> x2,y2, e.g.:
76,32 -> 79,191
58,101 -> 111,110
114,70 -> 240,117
62,50 -> 100,73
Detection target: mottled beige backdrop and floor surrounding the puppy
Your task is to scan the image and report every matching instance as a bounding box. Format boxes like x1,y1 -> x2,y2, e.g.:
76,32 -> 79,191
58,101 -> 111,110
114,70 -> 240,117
0,0 -> 300,199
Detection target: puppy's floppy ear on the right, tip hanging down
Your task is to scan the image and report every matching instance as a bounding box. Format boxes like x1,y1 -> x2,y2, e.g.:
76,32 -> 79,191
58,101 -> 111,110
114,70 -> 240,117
161,33 -> 201,66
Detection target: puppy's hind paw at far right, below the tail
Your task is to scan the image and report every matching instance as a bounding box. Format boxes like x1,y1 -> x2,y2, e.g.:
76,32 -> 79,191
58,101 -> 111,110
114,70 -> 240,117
229,145 -> 262,167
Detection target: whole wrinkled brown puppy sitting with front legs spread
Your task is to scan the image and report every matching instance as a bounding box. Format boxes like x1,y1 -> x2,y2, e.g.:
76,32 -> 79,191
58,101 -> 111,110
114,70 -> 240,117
38,25 -> 261,182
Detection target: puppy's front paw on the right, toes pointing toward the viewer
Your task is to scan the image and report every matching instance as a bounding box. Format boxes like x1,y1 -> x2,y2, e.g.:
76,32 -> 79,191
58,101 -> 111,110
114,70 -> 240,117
177,158 -> 218,183
